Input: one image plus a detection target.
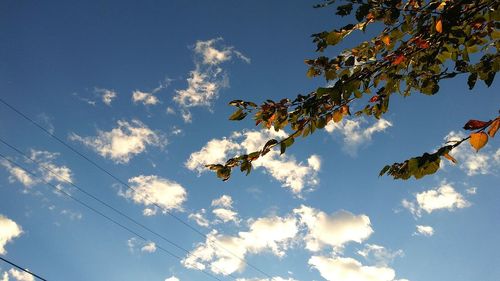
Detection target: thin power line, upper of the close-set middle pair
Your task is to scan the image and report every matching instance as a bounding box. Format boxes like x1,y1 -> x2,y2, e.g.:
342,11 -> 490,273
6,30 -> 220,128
0,137 -> 236,279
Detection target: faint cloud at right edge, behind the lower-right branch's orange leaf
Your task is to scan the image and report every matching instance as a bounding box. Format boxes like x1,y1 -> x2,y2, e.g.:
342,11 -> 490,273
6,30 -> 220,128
444,131 -> 494,176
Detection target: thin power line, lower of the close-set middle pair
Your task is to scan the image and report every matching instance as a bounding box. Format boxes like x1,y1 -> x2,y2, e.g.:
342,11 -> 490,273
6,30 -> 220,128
0,153 -> 222,281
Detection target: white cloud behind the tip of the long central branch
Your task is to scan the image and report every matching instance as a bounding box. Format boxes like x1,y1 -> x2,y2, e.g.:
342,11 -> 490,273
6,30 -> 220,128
185,130 -> 321,196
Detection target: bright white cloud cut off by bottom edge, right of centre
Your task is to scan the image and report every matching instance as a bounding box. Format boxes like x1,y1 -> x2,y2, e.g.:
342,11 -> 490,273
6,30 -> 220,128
309,256 -> 402,281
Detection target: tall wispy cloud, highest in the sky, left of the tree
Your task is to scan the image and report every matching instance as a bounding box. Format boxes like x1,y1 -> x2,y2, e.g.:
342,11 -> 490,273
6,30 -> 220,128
174,38 -> 250,122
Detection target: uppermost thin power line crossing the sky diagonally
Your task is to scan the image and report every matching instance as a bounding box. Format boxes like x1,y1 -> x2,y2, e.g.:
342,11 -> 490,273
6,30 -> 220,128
0,98 -> 273,279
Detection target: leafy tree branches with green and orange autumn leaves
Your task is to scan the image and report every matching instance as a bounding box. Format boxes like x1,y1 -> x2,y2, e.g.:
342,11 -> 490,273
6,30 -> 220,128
207,0 -> 500,180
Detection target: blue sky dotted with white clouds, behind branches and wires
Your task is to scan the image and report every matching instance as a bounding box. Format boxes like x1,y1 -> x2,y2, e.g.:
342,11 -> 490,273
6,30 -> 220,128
0,1 -> 500,281
